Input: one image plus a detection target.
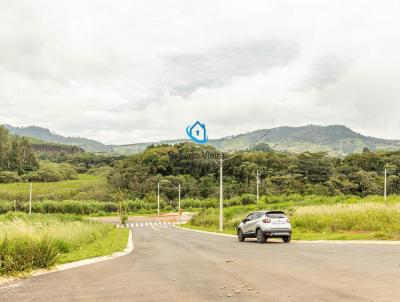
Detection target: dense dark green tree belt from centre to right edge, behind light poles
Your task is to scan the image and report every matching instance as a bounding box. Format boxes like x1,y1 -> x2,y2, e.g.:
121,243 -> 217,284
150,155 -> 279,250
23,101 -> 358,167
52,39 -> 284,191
108,143 -> 400,200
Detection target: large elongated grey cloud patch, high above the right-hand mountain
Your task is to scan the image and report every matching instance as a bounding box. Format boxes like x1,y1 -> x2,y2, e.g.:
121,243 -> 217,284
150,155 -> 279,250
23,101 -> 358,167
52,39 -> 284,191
165,39 -> 299,96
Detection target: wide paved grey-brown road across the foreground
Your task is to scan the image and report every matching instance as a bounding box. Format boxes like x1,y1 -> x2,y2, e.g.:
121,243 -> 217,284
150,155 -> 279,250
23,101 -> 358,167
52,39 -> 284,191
0,219 -> 400,302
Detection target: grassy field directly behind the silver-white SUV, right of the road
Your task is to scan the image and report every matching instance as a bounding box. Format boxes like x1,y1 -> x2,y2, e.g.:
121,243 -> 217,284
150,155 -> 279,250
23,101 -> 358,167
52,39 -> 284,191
185,199 -> 400,240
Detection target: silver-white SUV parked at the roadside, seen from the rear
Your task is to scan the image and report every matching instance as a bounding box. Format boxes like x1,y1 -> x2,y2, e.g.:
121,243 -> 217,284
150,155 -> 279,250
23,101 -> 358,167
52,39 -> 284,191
237,211 -> 292,243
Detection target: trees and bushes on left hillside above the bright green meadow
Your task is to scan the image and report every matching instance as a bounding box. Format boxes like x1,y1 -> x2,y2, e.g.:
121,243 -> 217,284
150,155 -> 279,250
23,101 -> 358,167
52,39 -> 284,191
0,126 -> 124,183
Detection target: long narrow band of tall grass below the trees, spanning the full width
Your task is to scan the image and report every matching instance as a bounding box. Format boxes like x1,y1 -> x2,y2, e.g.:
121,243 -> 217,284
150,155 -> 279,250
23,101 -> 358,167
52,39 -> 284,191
0,194 -> 400,215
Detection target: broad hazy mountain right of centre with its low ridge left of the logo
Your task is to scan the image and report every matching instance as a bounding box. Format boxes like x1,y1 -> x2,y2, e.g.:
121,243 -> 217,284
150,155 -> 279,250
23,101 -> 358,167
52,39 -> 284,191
113,125 -> 400,155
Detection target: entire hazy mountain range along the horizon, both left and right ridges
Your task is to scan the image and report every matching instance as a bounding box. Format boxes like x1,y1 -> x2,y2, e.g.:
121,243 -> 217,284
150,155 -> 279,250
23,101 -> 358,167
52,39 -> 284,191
6,125 -> 400,155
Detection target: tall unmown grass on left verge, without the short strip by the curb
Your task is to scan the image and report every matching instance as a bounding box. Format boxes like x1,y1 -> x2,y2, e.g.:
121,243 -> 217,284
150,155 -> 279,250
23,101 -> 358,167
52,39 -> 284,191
0,213 -> 113,275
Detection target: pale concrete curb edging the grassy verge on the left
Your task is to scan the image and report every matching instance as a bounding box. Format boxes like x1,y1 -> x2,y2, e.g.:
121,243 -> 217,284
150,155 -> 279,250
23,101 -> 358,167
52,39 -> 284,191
0,230 -> 134,285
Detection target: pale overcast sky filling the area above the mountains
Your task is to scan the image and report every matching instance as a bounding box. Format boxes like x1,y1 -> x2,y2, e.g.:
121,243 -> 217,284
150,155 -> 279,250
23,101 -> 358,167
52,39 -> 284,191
0,0 -> 400,143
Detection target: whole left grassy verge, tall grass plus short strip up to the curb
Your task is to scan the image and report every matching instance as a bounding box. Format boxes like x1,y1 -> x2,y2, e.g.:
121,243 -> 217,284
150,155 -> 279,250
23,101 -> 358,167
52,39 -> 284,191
0,213 -> 129,275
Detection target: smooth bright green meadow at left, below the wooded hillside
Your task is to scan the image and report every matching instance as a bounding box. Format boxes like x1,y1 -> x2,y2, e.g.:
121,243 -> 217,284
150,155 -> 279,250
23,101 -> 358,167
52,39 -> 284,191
0,174 -> 107,201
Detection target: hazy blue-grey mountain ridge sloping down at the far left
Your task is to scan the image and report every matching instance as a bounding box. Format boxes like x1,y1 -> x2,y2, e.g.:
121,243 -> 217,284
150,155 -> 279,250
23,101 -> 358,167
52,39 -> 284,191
4,125 -> 112,152
